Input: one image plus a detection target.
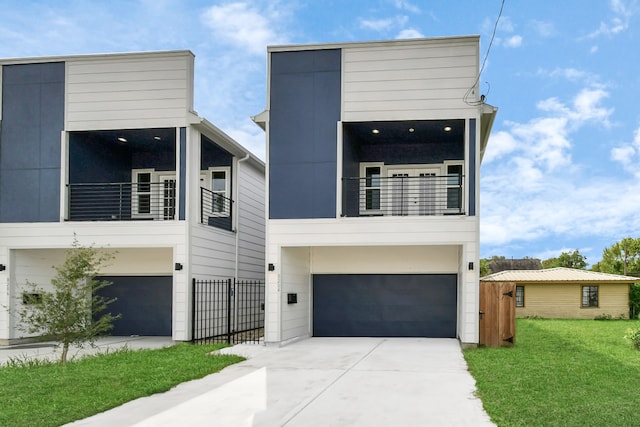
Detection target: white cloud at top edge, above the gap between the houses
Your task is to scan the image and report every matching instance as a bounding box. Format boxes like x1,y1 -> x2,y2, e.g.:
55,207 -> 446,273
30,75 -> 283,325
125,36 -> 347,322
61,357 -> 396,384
202,2 -> 286,55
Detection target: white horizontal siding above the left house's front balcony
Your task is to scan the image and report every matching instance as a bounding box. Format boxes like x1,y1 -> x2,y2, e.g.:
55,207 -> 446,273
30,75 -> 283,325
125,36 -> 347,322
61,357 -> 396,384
65,51 -> 194,130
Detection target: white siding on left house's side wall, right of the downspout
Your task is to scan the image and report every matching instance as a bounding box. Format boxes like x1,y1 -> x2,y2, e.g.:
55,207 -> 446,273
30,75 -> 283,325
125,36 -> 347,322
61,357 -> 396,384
235,162 -> 265,279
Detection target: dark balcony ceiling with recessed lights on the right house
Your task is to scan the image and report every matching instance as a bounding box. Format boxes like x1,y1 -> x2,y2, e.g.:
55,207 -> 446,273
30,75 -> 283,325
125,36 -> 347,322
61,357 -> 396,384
344,120 -> 464,145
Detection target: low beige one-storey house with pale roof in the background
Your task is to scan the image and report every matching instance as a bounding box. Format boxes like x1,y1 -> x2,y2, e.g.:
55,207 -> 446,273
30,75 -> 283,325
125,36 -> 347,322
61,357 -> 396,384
480,267 -> 640,319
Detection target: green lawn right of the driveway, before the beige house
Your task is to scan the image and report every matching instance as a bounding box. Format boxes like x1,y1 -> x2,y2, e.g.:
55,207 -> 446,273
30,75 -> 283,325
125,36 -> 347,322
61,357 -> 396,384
464,319 -> 640,427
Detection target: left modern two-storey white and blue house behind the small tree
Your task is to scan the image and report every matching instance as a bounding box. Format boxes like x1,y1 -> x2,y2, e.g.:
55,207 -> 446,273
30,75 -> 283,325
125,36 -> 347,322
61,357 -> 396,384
0,51 -> 265,344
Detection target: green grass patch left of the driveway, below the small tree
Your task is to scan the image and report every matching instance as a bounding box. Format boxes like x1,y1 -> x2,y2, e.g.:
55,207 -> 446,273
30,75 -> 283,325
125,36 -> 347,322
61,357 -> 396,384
0,344 -> 243,427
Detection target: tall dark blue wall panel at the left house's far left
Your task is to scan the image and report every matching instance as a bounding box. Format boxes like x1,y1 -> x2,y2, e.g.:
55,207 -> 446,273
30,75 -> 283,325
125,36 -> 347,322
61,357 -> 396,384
0,62 -> 65,222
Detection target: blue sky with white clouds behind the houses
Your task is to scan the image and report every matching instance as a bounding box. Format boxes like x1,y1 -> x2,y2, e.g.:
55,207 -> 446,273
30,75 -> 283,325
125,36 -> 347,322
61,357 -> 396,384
0,0 -> 640,263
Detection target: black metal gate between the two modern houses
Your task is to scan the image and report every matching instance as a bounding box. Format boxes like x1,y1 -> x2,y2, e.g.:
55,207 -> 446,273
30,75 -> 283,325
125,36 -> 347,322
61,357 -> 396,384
191,279 -> 264,344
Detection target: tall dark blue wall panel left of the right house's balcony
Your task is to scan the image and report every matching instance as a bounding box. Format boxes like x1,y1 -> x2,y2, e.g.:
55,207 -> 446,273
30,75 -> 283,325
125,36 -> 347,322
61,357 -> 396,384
269,49 -> 341,219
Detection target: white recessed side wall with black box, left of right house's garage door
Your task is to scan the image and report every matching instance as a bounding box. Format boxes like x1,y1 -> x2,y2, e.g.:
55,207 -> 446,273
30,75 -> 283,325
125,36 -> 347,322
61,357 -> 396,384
280,248 -> 311,341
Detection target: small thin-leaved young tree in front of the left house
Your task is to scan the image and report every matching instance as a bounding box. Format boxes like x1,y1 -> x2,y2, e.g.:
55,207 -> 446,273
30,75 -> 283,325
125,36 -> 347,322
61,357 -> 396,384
18,237 -> 120,365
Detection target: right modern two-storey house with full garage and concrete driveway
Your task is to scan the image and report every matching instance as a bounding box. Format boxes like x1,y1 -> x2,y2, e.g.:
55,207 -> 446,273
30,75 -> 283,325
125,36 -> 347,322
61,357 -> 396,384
254,36 -> 496,345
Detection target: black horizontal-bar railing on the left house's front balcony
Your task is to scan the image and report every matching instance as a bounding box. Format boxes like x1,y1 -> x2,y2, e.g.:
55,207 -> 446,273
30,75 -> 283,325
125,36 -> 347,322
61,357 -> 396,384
67,179 -> 176,221
